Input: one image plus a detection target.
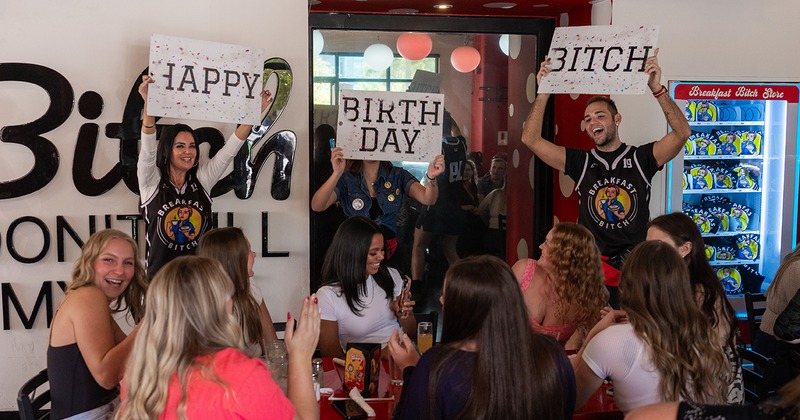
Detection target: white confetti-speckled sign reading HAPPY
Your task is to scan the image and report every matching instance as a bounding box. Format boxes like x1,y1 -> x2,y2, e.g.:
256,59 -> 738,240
147,34 -> 264,124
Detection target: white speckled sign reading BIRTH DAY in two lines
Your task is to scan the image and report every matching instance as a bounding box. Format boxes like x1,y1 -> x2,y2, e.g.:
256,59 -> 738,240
336,89 -> 444,162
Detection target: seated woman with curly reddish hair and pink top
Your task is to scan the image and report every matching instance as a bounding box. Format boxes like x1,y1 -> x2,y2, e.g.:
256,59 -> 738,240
512,223 -> 608,349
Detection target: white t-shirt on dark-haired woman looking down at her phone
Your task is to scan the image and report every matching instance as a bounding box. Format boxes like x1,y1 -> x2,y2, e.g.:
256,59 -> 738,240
317,268 -> 403,349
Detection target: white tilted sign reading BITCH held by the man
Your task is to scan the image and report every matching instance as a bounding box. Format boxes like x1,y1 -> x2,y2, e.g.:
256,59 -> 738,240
539,25 -> 659,94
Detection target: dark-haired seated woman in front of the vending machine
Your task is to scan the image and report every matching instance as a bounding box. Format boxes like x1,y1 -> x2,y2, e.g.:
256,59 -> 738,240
647,213 -> 744,404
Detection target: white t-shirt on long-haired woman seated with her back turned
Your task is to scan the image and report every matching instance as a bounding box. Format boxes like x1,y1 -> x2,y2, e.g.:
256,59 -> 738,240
583,324 -> 663,413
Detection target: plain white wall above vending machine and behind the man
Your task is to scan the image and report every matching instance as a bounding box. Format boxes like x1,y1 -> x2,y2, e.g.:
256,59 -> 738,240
613,0 -> 800,216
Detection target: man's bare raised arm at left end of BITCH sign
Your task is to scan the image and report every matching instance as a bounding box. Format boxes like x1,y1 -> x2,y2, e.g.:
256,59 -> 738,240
522,58 -> 567,172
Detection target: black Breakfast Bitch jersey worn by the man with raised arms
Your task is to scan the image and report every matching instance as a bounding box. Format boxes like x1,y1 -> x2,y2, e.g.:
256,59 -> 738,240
565,143 -> 661,257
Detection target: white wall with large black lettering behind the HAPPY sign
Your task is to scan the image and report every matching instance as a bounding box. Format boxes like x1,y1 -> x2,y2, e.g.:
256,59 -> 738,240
0,0 -> 309,411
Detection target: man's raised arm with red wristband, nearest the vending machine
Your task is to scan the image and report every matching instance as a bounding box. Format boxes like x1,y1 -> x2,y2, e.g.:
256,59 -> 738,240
644,48 -> 692,166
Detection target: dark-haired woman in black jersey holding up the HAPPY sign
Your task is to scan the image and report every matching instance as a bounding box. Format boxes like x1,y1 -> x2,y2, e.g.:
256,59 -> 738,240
136,75 -> 272,279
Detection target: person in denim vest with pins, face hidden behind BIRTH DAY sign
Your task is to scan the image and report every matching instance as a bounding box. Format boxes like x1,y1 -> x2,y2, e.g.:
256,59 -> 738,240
311,147 -> 444,259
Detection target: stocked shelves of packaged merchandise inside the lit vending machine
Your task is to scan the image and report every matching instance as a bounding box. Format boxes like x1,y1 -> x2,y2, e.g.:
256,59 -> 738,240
682,100 -> 769,294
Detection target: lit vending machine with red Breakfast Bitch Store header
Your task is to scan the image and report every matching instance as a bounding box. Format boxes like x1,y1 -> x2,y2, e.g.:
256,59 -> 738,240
667,82 -> 800,313
